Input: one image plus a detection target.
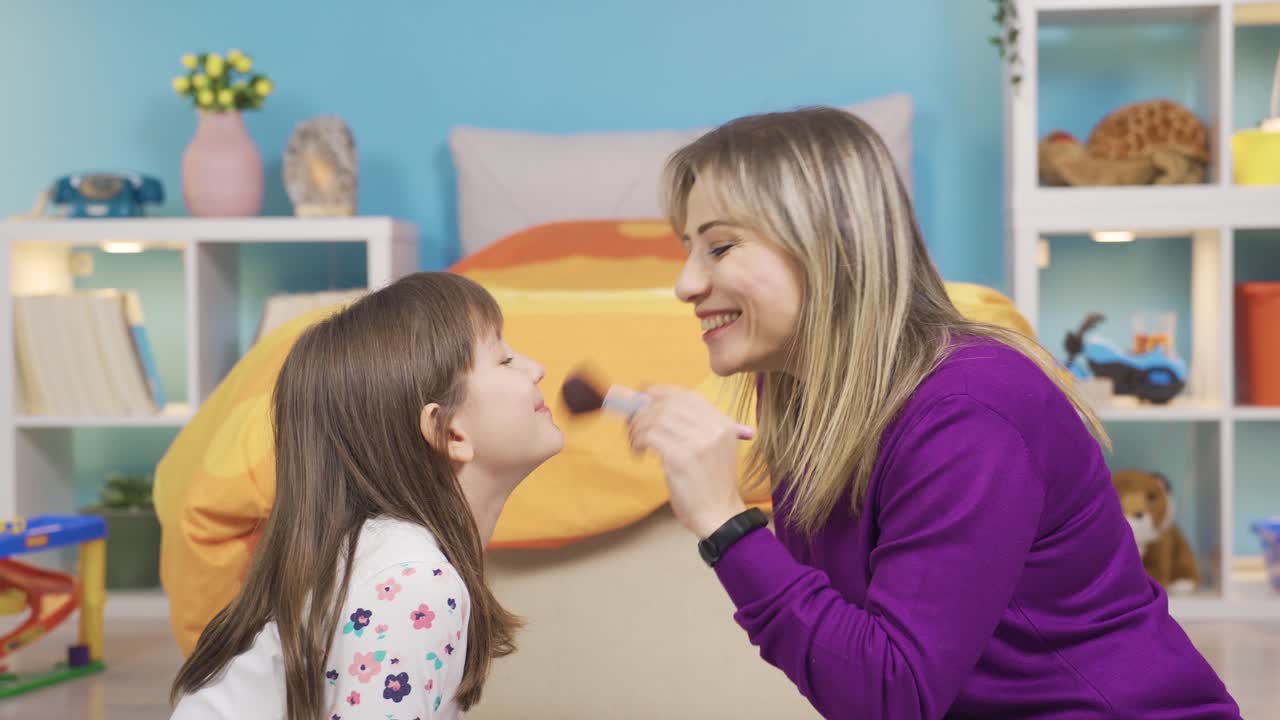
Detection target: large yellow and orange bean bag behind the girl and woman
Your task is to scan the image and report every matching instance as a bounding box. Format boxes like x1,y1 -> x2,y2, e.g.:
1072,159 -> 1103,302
155,222 -> 1030,652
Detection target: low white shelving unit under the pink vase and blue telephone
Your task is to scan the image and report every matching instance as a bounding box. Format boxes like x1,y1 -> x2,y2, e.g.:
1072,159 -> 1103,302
0,217 -> 417,618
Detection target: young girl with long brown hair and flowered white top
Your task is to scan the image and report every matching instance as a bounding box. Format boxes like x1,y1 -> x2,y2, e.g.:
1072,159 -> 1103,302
173,273 -> 563,720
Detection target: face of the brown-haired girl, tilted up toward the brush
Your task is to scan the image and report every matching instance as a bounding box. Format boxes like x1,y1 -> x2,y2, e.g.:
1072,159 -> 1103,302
453,333 -> 564,479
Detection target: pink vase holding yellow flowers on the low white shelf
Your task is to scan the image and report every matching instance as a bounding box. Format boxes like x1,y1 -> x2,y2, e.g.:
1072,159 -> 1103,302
182,110 -> 262,218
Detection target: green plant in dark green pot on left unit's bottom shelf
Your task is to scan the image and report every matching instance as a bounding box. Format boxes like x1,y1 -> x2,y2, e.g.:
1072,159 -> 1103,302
83,473 -> 160,589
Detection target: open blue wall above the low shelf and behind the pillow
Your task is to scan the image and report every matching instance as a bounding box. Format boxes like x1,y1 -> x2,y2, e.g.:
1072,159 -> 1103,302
0,0 -> 1002,284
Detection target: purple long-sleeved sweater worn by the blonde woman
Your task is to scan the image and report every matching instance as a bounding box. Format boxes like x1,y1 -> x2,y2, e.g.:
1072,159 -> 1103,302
716,341 -> 1239,720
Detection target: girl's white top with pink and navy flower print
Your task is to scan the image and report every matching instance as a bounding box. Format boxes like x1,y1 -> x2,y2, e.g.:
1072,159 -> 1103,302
173,518 -> 471,720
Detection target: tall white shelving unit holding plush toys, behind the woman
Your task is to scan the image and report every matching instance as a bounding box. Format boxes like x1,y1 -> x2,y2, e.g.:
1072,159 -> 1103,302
1005,0 -> 1280,620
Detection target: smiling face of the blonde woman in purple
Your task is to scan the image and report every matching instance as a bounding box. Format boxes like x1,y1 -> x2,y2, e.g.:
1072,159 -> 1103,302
676,182 -> 804,377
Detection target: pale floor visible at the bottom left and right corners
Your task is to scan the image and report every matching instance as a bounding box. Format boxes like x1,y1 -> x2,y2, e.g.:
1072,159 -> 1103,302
0,620 -> 1280,720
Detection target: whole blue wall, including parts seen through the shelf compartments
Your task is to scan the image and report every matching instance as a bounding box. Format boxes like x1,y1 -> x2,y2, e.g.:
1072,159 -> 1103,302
0,0 -> 1280,552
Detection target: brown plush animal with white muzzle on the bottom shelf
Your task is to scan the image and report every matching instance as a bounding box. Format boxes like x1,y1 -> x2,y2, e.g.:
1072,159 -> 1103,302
1111,469 -> 1199,593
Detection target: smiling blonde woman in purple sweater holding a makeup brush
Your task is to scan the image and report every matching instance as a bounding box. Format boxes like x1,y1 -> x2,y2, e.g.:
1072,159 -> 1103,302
630,109 -> 1239,720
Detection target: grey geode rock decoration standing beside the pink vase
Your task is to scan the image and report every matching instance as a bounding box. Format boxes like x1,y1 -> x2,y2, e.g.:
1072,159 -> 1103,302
284,115 -> 358,217
